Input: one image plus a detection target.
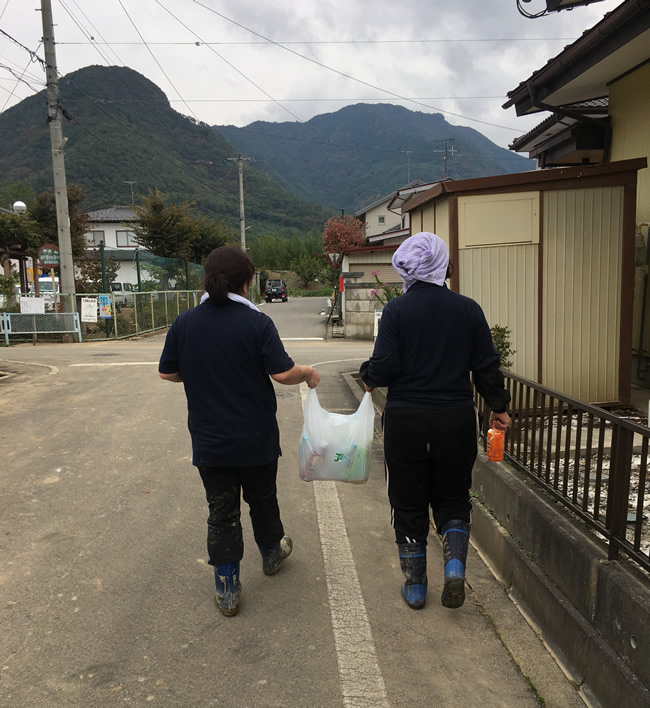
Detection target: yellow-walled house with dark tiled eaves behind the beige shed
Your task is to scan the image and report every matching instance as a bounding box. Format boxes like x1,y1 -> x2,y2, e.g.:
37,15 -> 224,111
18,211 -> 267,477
504,0 -> 650,385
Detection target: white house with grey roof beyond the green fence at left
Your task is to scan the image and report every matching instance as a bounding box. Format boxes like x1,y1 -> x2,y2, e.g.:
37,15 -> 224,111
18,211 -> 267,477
86,206 -> 138,285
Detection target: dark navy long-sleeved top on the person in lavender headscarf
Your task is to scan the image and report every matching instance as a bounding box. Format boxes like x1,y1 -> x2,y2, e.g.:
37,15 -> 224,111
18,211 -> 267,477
360,281 -> 510,413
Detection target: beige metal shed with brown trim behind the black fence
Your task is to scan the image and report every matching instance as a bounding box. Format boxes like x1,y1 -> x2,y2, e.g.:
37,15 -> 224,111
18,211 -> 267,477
402,158 -> 647,403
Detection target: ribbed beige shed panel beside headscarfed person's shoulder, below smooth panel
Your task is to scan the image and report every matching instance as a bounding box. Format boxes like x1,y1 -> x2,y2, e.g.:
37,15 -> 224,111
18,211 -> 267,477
459,245 -> 538,381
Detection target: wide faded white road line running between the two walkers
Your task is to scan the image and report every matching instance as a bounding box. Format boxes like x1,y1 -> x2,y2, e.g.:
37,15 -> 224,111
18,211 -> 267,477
300,384 -> 390,708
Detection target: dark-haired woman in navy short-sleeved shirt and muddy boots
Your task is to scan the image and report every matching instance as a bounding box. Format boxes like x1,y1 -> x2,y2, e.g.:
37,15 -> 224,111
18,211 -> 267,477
158,246 -> 320,616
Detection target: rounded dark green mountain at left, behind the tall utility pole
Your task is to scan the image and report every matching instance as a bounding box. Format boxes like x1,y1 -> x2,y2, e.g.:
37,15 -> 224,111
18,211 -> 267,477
0,66 -> 331,238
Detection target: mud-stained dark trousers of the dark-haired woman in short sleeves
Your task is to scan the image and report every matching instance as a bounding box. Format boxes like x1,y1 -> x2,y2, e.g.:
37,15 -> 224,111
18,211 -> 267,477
198,459 -> 284,565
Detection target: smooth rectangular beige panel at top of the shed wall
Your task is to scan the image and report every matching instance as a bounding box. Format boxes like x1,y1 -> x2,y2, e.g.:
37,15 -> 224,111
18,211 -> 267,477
458,192 -> 539,249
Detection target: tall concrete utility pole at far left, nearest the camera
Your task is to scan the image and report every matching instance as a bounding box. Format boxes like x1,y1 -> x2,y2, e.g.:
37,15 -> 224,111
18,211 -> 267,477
41,0 -> 76,312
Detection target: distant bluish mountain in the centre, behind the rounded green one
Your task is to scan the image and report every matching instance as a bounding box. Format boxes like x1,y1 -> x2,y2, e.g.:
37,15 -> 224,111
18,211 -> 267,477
215,104 -> 535,213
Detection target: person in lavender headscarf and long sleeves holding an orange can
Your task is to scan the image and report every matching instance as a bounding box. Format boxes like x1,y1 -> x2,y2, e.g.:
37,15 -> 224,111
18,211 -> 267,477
360,232 -> 510,609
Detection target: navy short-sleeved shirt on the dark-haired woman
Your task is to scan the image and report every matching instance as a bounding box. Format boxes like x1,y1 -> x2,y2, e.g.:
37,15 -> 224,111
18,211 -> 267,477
158,300 -> 293,467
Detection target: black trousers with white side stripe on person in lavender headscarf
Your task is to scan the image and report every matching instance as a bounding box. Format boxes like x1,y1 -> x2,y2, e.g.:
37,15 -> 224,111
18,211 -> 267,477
383,406 -> 477,543
